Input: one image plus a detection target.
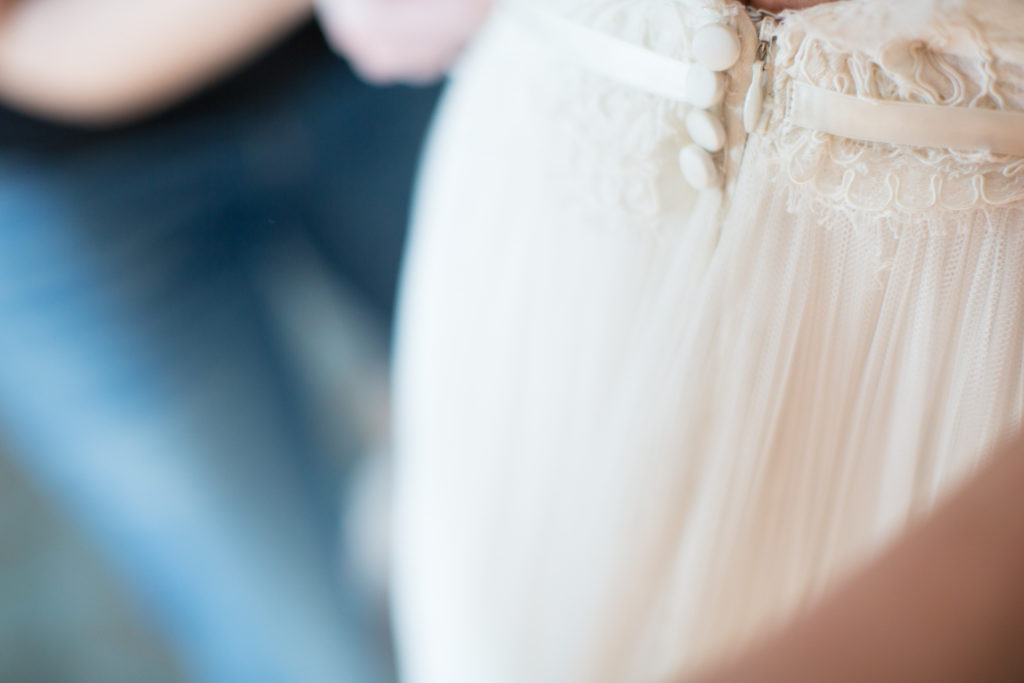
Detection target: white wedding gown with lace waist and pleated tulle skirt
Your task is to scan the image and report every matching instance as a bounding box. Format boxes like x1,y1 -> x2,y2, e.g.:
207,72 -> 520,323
394,0 -> 1024,683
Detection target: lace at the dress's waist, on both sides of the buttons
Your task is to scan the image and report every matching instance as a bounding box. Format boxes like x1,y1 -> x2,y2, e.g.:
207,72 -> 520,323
520,0 -> 1024,222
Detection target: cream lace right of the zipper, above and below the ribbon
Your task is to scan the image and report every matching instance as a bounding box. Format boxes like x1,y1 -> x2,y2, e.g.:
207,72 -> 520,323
762,3 -> 1024,220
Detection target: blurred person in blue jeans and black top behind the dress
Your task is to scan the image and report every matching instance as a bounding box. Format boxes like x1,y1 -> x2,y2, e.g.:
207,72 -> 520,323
0,0 -> 434,683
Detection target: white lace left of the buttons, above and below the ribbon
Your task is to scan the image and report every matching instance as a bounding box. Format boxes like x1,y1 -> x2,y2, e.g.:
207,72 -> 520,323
520,0 -> 738,230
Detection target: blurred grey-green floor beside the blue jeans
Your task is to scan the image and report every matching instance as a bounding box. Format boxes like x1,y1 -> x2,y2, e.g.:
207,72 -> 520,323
0,454 -> 185,683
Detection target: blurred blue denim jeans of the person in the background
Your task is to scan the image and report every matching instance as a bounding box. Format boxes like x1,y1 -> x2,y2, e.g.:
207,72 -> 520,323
0,42 -> 432,683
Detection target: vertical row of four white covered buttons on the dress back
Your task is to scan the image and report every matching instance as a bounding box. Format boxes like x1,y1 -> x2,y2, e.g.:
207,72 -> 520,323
679,24 -> 741,189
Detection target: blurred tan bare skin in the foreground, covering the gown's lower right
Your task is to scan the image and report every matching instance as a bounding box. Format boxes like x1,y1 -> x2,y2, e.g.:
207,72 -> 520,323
687,436 -> 1024,683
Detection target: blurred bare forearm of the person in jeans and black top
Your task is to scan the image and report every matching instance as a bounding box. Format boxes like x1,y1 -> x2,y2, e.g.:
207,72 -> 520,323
0,0 -> 312,126
